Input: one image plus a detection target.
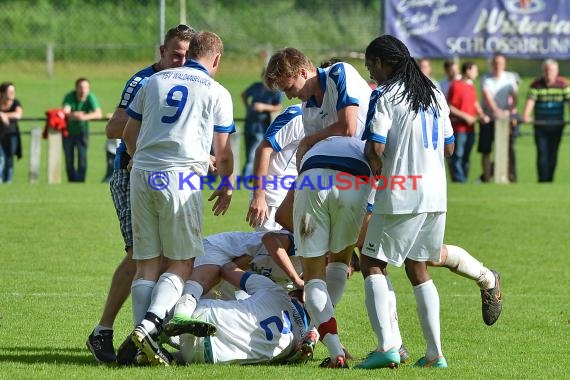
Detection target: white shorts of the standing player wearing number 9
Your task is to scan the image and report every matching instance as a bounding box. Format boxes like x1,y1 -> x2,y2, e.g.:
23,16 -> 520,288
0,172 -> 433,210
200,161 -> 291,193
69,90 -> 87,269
130,169 -> 204,260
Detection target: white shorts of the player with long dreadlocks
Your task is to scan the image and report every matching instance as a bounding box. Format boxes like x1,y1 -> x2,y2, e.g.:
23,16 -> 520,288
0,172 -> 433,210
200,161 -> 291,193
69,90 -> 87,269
361,212 -> 446,266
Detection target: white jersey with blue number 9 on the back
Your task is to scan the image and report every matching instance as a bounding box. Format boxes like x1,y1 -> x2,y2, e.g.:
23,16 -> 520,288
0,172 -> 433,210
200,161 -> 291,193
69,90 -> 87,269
127,60 -> 235,175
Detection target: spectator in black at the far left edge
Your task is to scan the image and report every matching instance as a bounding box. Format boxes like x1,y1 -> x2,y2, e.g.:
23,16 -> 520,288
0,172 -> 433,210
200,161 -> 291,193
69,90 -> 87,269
0,82 -> 23,183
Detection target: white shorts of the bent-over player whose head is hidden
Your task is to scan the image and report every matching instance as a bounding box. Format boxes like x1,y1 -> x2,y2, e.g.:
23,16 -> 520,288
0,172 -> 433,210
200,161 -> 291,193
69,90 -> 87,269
293,169 -> 370,257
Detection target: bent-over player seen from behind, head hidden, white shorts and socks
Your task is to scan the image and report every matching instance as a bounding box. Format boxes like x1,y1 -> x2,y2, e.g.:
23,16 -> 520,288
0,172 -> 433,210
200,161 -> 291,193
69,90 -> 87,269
286,136 -> 370,368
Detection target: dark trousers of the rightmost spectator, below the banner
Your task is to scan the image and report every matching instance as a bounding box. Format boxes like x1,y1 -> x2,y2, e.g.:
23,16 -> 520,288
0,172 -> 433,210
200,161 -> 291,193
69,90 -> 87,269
534,125 -> 564,182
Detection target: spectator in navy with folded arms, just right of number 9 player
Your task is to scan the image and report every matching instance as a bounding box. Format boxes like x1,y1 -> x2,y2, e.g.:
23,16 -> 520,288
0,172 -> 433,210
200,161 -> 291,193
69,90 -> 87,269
241,69 -> 283,177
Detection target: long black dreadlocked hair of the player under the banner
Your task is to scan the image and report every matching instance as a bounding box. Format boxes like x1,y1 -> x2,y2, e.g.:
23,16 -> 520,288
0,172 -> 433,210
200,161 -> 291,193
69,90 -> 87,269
365,34 -> 440,113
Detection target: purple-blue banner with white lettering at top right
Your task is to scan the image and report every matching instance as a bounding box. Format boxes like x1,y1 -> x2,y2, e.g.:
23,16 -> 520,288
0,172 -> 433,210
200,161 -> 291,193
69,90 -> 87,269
384,0 -> 570,59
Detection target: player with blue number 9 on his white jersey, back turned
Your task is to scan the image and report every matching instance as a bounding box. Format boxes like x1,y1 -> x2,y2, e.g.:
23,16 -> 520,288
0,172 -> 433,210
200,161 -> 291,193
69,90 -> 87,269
123,32 -> 235,363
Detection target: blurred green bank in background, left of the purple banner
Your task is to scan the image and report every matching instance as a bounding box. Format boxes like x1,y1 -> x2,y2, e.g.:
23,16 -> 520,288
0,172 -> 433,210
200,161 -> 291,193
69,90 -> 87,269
0,0 -> 380,61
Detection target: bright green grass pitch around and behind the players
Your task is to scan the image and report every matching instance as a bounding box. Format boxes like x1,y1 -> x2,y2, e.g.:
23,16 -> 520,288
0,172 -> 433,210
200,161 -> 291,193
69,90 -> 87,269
0,60 -> 570,379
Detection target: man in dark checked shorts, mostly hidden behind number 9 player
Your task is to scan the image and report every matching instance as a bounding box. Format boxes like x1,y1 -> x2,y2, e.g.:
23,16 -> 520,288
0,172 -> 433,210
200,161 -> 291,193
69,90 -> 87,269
87,24 -> 195,364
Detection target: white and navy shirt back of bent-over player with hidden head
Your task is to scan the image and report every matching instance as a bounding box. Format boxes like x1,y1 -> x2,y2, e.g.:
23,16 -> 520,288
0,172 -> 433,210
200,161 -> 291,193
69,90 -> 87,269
301,136 -> 371,177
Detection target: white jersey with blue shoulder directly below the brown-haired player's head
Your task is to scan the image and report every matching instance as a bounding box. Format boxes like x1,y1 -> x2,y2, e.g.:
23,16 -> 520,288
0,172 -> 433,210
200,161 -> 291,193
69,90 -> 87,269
263,104 -> 305,207
